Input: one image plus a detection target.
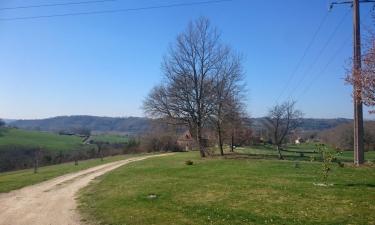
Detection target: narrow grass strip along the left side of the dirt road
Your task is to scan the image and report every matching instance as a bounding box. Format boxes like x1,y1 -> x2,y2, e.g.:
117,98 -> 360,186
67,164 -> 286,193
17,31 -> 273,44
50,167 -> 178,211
0,155 -> 142,193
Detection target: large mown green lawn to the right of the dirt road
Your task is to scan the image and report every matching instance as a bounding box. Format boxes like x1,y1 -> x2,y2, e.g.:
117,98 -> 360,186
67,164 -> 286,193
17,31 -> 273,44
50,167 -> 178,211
79,152 -> 375,225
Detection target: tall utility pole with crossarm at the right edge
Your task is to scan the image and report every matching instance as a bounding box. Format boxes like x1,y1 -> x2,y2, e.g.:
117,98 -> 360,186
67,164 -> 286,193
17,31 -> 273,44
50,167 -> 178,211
330,0 -> 375,165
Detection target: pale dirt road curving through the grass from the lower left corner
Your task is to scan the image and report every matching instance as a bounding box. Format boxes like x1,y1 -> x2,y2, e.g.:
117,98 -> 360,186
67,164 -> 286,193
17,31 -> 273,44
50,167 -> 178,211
0,154 -> 166,225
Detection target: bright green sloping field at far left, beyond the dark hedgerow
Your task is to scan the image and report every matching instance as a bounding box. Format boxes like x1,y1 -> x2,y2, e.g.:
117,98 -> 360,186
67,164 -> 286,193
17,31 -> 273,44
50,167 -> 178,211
0,128 -> 83,151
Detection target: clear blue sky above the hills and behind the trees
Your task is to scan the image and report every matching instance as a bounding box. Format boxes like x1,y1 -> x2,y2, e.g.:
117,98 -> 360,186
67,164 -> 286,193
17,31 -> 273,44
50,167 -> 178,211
0,0 -> 374,119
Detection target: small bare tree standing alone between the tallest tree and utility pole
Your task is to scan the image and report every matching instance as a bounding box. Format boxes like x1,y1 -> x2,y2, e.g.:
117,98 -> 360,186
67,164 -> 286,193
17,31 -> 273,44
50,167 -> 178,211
266,101 -> 302,159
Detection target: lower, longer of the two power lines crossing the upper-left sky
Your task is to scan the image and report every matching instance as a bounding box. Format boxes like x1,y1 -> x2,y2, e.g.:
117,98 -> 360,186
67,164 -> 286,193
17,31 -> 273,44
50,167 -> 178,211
0,0 -> 234,21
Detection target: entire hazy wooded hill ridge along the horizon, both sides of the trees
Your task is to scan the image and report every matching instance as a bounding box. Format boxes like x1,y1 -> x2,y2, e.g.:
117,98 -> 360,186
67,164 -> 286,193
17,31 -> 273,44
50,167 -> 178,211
9,116 -> 352,135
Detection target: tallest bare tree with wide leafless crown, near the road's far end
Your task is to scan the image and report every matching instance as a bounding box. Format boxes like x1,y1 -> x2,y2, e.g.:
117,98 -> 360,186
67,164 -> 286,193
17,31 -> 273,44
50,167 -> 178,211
143,18 -> 244,157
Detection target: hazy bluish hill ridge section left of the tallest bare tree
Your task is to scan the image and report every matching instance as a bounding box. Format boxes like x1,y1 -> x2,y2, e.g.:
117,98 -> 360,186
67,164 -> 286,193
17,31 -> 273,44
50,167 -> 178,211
10,116 -> 151,134
